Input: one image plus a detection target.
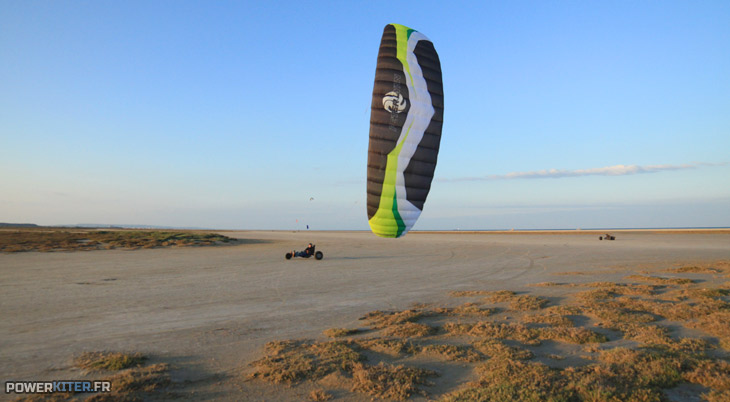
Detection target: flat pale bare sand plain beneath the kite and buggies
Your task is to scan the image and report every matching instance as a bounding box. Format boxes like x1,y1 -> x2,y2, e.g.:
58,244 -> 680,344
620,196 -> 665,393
0,231 -> 730,400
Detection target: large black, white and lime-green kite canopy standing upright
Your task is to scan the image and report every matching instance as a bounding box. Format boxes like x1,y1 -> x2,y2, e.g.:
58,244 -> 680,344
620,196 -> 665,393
367,24 -> 444,237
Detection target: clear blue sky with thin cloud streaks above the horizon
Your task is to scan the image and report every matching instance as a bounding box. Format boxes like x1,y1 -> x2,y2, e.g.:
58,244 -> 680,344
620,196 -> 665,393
0,0 -> 730,230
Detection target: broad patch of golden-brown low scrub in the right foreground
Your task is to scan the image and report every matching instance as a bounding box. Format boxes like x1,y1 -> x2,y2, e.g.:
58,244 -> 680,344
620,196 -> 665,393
246,263 -> 730,402
